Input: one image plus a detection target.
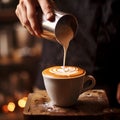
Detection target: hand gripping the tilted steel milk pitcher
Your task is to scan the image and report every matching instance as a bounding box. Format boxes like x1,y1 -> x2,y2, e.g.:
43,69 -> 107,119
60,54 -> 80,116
15,0 -> 55,37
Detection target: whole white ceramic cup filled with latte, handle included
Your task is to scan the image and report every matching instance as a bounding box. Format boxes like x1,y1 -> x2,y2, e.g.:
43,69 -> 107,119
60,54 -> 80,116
42,66 -> 96,107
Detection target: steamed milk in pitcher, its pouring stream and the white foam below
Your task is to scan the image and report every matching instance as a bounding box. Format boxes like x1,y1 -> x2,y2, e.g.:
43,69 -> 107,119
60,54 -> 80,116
50,24 -> 80,76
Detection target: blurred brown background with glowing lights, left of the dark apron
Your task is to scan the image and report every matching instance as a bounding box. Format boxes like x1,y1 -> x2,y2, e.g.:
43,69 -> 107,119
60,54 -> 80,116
0,0 -> 42,120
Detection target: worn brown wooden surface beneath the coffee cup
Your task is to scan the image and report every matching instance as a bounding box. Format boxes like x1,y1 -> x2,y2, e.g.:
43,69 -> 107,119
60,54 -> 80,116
23,89 -> 120,120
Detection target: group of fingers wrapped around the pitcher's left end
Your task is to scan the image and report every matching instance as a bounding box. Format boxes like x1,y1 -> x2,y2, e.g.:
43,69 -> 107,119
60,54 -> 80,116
15,0 -> 42,37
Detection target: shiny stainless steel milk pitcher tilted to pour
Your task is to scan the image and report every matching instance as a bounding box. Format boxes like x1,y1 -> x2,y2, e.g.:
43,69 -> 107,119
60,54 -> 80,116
41,11 -> 78,43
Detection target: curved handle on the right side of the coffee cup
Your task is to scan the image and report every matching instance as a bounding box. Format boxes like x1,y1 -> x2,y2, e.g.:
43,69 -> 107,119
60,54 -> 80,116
81,75 -> 96,92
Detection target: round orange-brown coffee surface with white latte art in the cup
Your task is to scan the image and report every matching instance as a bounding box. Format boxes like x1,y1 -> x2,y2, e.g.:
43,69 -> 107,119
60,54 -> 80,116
42,66 -> 86,79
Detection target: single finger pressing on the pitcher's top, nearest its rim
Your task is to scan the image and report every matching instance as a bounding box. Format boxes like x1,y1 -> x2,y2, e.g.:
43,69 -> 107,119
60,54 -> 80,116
38,0 -> 55,21
